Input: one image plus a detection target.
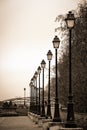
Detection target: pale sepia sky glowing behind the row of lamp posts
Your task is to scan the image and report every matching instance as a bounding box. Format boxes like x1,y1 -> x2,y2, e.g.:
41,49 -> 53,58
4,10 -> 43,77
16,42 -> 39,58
0,0 -> 79,100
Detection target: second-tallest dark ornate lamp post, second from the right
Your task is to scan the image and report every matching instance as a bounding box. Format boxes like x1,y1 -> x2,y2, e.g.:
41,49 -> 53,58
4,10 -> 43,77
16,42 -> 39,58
53,36 -> 61,122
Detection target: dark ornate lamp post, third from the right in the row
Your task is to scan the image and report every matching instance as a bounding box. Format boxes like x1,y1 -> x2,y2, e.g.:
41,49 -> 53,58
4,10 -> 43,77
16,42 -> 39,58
47,50 -> 53,118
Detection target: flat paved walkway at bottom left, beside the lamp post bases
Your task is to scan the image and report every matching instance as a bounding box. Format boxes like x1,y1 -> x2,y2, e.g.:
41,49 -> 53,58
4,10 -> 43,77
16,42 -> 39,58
0,116 -> 42,130
